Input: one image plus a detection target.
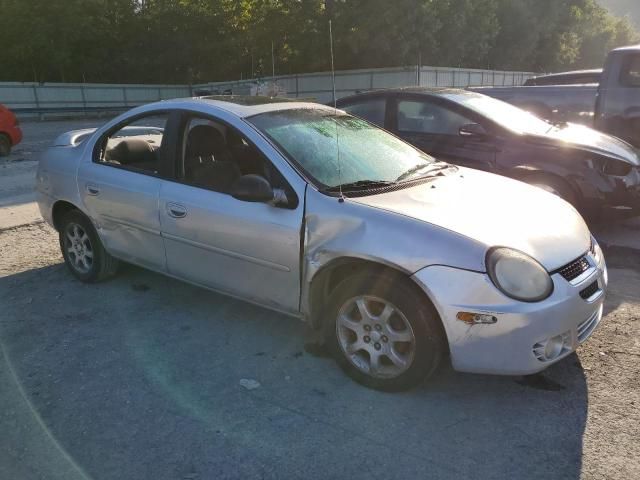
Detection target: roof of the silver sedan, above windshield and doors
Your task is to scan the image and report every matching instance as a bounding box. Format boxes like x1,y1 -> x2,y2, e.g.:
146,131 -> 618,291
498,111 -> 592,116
160,95 -> 336,118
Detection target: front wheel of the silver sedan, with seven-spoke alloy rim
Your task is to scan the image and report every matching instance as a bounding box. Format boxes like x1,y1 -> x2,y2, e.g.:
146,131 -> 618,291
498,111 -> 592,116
325,273 -> 444,391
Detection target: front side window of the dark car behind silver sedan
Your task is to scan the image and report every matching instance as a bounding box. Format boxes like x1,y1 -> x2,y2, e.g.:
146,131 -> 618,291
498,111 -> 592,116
398,100 -> 474,135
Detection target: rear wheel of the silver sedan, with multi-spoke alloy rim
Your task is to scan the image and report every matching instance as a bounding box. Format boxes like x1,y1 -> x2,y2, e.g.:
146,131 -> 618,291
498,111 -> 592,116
59,210 -> 118,283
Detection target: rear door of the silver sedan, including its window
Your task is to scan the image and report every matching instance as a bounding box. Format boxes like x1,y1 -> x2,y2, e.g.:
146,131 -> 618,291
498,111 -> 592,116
78,111 -> 181,272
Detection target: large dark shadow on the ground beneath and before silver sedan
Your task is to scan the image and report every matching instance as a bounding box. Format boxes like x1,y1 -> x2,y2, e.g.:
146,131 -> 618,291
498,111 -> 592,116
0,265 -> 587,479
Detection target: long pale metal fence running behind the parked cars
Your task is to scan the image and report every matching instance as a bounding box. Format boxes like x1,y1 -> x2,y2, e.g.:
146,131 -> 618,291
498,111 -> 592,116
0,67 -> 533,114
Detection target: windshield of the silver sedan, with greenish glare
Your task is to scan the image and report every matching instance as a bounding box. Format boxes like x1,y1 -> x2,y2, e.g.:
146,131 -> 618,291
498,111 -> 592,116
249,109 -> 434,188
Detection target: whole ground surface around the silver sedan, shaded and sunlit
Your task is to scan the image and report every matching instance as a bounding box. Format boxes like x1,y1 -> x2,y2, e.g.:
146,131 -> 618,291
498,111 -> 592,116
0,119 -> 640,480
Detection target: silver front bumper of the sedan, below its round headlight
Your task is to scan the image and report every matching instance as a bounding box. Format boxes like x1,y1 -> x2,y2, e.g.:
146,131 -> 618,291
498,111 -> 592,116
413,249 -> 608,375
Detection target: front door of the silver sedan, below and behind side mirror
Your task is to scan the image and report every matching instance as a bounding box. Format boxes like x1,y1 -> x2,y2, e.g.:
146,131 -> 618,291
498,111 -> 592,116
160,111 -> 305,313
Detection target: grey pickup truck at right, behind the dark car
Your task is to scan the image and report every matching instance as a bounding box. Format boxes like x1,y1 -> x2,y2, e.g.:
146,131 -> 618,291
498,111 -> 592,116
472,45 -> 640,148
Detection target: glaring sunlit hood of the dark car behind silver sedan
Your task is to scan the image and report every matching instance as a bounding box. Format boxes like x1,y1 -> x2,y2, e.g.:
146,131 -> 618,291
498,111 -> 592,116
531,123 -> 640,166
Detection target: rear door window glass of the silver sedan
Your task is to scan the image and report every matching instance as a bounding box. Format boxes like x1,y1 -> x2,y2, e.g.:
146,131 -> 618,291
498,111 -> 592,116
97,113 -> 169,175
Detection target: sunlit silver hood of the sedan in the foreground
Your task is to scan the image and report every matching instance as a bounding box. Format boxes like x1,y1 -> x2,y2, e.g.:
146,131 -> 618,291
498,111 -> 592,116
350,168 -> 591,271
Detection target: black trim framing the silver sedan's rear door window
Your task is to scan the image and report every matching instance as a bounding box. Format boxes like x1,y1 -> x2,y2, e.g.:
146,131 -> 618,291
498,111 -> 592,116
91,109 -> 176,179
